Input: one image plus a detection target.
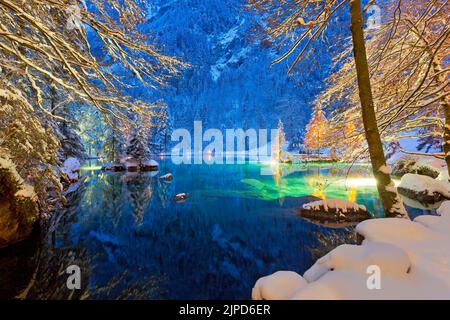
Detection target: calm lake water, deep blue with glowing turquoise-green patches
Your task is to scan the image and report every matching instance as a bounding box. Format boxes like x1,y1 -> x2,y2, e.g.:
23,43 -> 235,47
0,159 -> 432,299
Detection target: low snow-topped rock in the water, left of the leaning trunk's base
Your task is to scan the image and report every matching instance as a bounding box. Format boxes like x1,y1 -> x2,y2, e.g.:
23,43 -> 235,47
299,199 -> 371,223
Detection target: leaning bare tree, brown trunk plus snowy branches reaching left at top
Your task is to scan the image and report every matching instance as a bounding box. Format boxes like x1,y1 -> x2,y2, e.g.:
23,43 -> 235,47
248,0 -> 406,217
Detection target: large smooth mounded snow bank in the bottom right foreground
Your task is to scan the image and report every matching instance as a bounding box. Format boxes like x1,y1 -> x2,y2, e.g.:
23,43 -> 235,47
252,201 -> 450,300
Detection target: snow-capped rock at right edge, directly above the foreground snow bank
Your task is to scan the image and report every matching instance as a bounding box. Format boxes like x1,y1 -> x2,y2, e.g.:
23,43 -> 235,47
398,173 -> 450,203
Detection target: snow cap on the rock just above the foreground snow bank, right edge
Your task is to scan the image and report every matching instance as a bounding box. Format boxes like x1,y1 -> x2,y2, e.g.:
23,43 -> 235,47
398,173 -> 450,199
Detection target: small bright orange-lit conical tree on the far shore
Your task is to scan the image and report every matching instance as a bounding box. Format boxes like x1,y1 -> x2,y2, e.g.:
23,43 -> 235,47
305,105 -> 329,154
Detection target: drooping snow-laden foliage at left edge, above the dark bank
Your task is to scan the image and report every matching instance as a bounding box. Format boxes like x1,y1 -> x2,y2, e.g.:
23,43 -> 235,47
0,81 -> 61,211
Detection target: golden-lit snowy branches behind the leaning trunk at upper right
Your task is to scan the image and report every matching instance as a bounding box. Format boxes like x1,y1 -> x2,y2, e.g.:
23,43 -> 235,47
317,0 -> 450,172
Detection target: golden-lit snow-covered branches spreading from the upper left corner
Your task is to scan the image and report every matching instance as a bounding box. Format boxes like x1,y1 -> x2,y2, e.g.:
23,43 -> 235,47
0,0 -> 184,125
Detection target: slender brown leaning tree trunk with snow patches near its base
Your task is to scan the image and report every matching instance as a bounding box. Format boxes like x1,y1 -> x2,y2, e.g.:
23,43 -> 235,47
350,0 -> 406,217
